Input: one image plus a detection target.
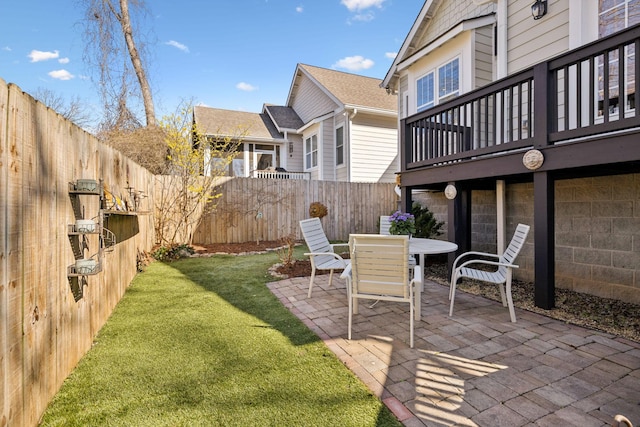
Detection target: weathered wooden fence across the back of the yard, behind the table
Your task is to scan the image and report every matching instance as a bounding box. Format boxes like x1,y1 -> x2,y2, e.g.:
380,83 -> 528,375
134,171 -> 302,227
193,178 -> 398,244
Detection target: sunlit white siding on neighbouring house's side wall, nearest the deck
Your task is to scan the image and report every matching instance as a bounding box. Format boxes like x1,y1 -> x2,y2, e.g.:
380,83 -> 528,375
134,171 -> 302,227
351,115 -> 398,182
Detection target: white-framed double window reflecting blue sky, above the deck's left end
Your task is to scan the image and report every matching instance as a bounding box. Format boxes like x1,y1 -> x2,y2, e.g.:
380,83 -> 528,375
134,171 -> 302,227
416,58 -> 460,111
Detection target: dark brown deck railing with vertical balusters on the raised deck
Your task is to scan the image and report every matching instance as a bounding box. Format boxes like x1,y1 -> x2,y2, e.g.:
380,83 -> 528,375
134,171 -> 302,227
400,26 -> 640,170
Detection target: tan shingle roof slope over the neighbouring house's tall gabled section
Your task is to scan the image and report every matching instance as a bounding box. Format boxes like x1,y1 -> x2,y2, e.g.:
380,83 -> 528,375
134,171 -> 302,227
298,64 -> 398,111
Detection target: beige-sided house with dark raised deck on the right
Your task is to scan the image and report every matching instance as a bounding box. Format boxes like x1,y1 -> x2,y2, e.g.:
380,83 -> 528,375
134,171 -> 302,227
382,0 -> 640,308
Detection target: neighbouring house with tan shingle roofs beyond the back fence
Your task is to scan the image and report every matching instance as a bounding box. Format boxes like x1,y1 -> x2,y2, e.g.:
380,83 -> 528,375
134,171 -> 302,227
194,64 -> 398,182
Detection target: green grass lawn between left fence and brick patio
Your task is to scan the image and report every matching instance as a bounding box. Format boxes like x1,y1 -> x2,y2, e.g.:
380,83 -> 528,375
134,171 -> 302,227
42,248 -> 401,426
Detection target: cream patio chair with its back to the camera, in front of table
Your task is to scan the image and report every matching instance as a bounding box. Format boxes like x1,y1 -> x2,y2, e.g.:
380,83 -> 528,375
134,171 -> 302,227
341,234 -> 422,348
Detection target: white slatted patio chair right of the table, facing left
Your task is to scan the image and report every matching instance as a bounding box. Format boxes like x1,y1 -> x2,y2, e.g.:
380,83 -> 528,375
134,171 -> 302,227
449,224 -> 530,323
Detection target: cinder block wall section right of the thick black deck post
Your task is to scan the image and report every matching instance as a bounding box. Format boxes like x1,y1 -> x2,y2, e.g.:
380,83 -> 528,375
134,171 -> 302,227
556,174 -> 640,303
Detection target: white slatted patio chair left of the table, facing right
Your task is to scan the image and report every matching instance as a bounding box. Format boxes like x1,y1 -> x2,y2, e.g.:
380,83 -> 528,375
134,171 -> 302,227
300,218 -> 349,298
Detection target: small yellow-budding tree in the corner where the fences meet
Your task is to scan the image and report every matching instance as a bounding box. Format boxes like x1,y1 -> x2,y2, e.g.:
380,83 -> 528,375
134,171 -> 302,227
155,101 -> 242,246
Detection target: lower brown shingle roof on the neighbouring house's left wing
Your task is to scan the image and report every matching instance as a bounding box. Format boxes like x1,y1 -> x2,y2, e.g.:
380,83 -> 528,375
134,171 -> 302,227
193,106 -> 282,139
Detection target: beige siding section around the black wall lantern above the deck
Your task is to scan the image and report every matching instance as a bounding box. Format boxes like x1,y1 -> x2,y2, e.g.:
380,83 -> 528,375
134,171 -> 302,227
507,0 -> 569,74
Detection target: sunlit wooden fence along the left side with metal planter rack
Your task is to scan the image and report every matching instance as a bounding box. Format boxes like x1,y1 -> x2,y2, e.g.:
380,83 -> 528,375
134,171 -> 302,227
0,79 -> 154,426
